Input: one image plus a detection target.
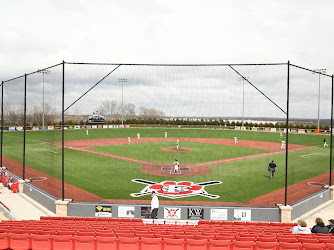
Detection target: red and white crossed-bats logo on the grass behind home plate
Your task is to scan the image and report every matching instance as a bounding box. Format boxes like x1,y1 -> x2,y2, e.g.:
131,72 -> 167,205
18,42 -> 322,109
130,179 -> 222,199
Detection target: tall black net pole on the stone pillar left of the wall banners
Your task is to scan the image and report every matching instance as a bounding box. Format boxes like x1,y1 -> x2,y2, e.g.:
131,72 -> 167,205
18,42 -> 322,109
61,61 -> 65,200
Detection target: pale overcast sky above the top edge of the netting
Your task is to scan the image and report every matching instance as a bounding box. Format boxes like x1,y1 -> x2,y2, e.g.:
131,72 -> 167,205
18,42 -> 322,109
0,0 -> 334,119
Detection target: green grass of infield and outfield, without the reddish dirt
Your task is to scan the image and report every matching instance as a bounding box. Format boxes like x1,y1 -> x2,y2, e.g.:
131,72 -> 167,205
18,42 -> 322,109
3,128 -> 329,202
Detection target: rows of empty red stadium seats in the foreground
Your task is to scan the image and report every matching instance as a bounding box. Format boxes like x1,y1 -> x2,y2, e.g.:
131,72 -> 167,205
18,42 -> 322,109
0,216 -> 334,250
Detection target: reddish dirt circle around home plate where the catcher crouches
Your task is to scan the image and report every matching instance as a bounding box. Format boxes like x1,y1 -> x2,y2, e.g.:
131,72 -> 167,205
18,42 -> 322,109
140,164 -> 212,177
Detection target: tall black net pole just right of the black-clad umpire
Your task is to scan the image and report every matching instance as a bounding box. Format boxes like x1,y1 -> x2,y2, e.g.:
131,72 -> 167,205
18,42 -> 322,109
284,61 -> 290,206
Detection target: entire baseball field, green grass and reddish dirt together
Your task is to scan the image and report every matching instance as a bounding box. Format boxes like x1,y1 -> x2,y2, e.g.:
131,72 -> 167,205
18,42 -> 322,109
3,127 -> 330,206
